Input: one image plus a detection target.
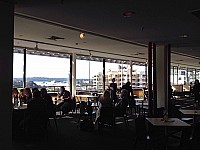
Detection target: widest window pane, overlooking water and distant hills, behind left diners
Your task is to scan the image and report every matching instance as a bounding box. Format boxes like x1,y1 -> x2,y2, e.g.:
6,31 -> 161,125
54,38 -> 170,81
26,54 -> 70,91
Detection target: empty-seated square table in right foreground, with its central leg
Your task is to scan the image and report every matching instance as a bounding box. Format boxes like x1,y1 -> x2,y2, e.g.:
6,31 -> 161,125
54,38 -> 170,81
146,118 -> 191,149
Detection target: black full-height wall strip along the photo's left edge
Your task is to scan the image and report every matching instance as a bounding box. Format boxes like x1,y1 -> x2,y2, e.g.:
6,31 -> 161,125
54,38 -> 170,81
0,0 -> 14,150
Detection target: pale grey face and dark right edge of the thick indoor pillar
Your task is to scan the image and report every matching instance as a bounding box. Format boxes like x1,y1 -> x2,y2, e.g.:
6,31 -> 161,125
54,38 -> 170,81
156,45 -> 171,111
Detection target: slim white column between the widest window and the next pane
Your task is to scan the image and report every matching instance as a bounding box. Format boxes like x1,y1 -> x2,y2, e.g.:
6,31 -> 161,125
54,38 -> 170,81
72,53 -> 76,96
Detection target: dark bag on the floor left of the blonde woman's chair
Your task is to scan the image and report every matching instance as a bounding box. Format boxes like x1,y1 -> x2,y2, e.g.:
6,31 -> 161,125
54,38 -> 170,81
79,118 -> 94,131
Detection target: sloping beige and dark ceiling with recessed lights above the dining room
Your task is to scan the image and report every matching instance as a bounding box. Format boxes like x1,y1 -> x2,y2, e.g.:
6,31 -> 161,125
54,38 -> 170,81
14,0 -> 200,67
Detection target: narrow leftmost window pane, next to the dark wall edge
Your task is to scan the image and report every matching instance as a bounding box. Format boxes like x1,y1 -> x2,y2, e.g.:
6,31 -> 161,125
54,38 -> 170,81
13,53 -> 24,88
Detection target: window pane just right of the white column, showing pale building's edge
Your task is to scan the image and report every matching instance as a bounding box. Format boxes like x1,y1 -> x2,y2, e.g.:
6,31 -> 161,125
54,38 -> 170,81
76,56 -> 103,94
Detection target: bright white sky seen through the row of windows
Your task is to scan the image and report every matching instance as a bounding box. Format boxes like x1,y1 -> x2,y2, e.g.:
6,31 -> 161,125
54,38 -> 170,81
13,53 -> 144,79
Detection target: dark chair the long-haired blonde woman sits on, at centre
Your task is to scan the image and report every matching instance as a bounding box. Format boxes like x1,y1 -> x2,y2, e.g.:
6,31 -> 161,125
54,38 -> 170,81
97,107 -> 115,131
